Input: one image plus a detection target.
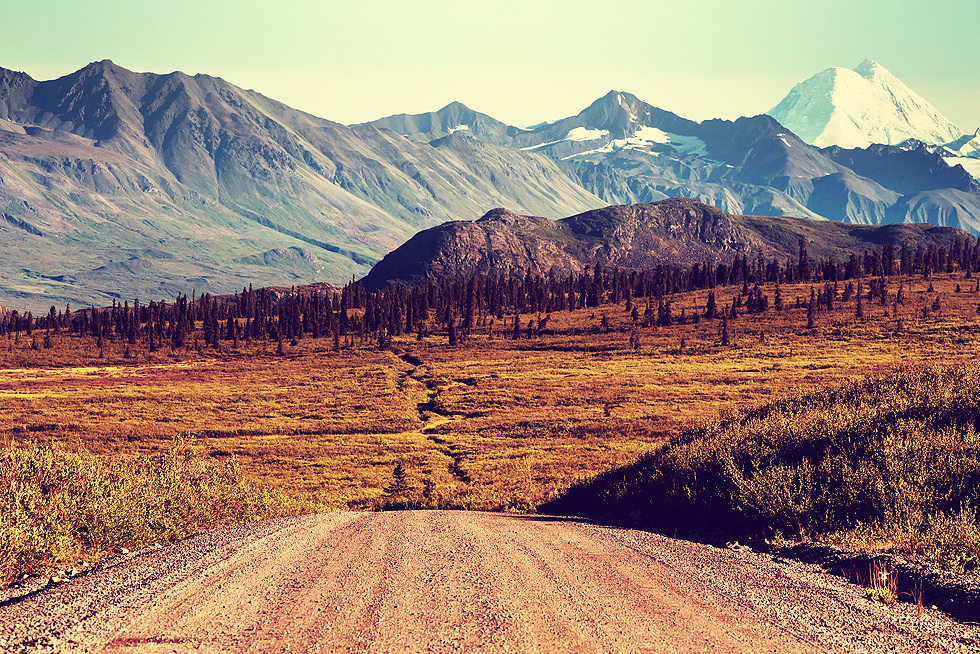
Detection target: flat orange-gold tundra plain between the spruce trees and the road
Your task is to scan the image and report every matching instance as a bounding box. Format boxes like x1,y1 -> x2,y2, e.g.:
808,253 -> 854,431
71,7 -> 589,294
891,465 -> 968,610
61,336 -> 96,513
0,274 -> 980,588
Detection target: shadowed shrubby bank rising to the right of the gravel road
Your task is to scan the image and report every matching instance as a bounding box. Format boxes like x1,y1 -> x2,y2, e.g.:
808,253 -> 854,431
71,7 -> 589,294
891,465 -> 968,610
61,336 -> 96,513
548,365 -> 980,571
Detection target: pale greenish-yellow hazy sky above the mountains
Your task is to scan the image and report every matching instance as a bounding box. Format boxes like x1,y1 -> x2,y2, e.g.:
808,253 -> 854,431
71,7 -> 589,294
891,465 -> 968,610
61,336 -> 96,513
0,0 -> 980,132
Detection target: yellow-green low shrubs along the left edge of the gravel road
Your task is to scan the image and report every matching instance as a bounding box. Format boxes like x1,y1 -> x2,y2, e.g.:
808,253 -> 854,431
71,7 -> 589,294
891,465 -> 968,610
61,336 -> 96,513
0,446 -> 292,587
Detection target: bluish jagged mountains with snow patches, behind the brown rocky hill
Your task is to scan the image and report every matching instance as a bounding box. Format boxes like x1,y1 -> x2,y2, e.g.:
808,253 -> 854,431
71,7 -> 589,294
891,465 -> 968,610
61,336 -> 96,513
372,81 -> 980,234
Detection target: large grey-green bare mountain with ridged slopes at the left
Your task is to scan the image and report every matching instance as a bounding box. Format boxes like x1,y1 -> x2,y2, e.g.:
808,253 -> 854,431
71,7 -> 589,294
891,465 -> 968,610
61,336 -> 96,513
0,61 -> 602,308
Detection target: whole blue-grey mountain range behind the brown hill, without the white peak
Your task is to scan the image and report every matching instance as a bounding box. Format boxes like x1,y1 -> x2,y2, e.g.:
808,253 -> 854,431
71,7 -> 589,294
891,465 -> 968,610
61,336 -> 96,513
0,61 -> 980,309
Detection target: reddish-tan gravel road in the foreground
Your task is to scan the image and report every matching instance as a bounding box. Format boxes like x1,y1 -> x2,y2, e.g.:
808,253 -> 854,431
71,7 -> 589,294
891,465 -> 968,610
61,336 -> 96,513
0,511 -> 980,653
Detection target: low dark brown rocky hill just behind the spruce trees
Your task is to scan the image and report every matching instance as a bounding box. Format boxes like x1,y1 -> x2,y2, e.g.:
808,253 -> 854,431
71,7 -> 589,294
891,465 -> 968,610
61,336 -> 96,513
363,198 -> 967,290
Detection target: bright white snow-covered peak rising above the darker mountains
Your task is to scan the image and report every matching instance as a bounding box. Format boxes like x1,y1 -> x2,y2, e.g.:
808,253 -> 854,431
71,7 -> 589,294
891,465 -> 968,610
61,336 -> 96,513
768,59 -> 963,148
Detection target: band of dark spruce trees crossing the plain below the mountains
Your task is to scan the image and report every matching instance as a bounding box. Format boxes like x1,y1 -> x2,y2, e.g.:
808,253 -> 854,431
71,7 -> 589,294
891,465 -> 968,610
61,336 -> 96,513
0,237 -> 980,352
